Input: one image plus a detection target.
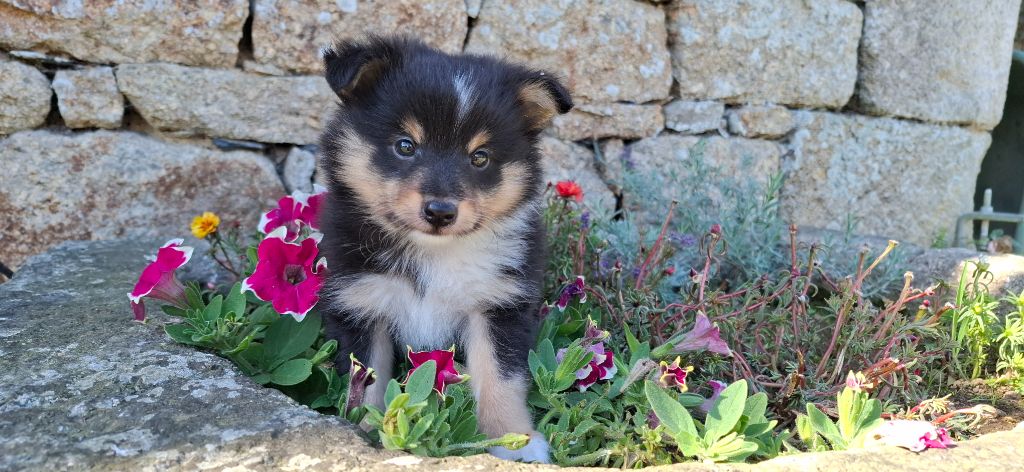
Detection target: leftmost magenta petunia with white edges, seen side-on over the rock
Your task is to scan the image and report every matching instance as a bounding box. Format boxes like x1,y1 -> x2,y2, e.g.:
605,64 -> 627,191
128,240 -> 193,321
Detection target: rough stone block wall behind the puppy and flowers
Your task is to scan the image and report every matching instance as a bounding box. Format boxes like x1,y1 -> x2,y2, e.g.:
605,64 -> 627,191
0,0 -> 1021,266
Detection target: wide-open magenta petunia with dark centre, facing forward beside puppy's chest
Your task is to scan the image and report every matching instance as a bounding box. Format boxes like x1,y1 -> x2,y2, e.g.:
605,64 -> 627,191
242,227 -> 327,321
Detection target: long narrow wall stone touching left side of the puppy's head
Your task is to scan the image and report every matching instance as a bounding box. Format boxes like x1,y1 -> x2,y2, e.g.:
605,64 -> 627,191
117,63 -> 338,144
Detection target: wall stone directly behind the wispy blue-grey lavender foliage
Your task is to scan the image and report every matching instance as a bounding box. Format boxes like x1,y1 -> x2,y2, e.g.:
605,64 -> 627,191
605,135 -> 782,223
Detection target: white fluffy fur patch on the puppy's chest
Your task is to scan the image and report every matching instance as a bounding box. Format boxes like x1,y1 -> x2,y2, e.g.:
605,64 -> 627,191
334,206 -> 540,350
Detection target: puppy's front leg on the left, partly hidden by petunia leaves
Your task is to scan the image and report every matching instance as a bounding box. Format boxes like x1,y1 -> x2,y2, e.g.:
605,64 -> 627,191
324,312 -> 394,410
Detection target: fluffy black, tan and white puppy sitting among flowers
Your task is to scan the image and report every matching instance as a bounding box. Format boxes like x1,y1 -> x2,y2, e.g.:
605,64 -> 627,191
319,37 -> 572,462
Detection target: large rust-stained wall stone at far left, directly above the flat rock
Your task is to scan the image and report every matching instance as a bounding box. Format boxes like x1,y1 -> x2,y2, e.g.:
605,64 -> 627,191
0,130 -> 284,266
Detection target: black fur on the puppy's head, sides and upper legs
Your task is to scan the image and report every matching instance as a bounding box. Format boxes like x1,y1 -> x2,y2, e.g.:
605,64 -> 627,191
321,37 -> 572,381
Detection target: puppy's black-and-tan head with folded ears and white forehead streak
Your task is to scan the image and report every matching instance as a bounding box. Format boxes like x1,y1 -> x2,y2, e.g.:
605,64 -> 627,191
323,39 -> 571,237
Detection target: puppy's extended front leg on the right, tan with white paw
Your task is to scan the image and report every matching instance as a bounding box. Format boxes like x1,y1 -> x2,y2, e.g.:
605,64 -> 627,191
465,310 -> 550,463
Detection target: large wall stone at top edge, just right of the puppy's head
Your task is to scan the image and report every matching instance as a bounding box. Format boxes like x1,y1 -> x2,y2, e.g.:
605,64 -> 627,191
466,0 -> 672,103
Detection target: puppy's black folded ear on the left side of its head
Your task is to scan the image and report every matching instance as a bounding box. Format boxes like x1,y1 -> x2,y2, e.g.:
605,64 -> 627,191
323,37 -> 400,102
